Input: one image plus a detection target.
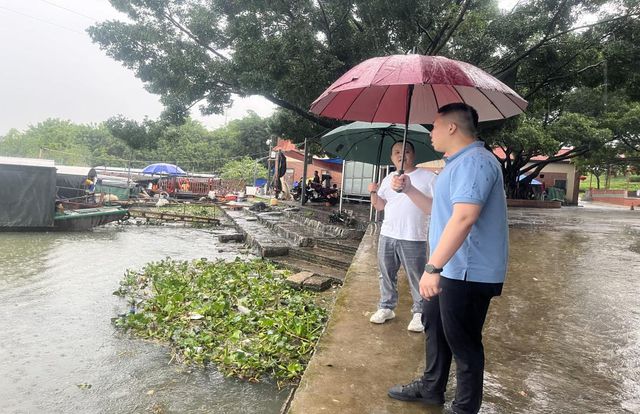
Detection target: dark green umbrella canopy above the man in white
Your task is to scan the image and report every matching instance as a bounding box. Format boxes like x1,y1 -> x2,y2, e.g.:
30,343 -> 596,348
321,122 -> 442,165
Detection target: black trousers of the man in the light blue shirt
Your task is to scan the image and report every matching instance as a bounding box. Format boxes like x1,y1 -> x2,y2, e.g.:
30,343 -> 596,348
422,276 -> 502,414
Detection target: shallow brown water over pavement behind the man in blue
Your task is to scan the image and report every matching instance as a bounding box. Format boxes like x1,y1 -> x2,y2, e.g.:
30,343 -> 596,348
481,207 -> 640,414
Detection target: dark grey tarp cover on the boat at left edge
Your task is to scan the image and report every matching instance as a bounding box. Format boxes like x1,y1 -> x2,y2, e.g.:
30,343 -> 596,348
0,161 -> 56,230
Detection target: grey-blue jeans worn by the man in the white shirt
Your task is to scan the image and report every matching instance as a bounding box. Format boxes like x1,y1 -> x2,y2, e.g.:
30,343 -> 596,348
378,235 -> 427,313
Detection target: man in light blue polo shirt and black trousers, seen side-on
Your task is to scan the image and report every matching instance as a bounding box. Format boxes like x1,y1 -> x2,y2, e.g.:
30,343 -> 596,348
389,103 -> 508,414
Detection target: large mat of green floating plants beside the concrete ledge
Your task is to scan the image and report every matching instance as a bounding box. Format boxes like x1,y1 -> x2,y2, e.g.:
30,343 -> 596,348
114,259 -> 327,385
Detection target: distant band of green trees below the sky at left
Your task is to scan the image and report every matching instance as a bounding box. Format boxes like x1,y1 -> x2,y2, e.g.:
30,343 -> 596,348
0,113 -> 270,177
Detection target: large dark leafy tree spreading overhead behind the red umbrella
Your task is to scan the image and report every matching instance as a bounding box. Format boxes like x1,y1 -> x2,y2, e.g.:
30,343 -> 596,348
89,0 -> 640,197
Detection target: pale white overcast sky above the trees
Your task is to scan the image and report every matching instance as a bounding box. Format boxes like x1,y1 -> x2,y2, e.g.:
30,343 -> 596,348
0,0 -> 516,135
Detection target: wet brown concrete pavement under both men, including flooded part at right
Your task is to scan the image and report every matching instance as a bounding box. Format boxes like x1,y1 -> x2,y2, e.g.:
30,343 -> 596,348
290,208 -> 640,414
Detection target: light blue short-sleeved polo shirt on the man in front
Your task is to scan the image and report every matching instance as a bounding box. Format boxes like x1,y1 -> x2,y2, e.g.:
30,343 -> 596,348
429,142 -> 509,283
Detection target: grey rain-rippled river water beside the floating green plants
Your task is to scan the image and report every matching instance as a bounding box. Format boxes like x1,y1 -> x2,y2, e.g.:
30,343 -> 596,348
0,226 -> 289,414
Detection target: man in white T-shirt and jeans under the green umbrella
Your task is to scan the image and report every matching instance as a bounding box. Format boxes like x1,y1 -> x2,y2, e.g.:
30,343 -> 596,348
369,142 -> 436,332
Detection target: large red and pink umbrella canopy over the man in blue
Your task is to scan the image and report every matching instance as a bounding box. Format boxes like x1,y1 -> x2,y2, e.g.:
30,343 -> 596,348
311,55 -> 527,124
